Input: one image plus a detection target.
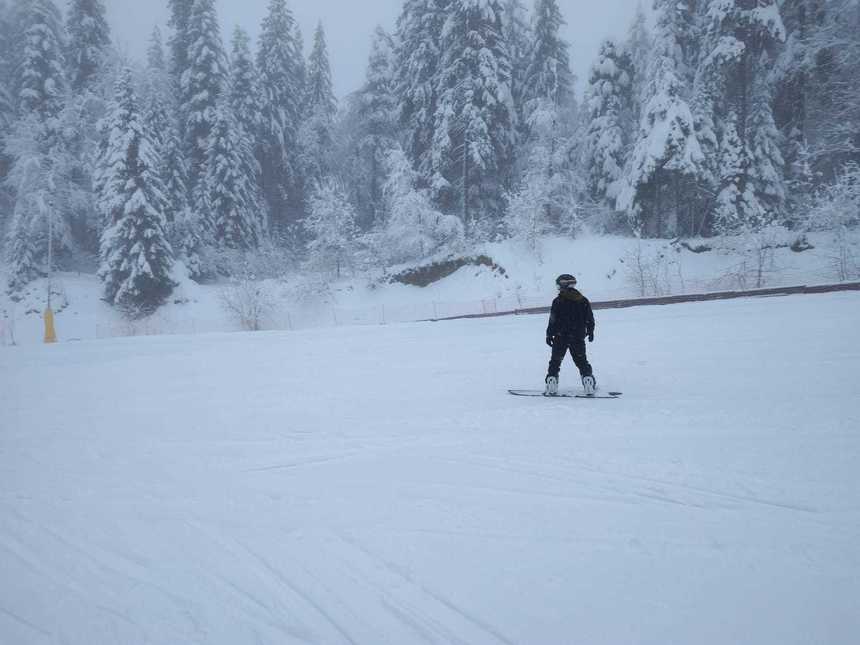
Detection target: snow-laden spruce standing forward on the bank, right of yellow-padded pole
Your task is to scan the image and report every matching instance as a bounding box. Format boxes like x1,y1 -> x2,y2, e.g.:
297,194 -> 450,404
98,69 -> 174,316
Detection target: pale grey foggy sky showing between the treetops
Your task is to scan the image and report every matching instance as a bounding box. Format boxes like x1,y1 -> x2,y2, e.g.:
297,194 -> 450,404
105,0 -> 650,97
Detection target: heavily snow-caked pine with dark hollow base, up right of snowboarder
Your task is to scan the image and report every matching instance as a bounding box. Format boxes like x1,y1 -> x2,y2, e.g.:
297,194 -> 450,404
616,0 -> 706,237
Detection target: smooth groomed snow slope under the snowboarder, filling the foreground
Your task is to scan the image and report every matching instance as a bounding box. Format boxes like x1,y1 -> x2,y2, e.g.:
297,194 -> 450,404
0,293 -> 860,645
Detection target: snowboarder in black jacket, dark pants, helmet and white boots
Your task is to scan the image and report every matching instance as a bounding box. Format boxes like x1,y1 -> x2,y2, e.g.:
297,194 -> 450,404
545,273 -> 597,396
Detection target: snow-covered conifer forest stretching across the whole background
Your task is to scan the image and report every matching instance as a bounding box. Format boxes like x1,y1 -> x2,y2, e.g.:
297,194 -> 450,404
0,0 -> 860,314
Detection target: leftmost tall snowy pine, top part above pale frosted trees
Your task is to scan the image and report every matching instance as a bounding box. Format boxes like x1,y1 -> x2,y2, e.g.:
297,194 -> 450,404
18,0 -> 66,120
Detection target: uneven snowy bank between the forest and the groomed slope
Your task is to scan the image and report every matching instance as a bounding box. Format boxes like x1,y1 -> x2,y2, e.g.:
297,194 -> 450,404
0,230 -> 860,344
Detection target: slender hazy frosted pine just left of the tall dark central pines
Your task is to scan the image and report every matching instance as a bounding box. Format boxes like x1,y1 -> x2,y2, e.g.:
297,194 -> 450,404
350,27 -> 397,229
